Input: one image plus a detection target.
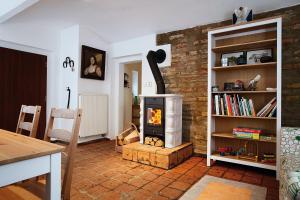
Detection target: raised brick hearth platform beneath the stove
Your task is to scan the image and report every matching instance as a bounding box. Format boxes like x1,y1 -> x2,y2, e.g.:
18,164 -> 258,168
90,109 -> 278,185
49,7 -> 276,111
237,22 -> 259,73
122,142 -> 193,169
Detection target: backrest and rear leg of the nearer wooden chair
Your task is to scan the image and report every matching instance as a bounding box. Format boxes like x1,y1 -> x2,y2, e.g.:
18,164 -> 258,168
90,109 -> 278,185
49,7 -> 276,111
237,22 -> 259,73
44,108 -> 82,199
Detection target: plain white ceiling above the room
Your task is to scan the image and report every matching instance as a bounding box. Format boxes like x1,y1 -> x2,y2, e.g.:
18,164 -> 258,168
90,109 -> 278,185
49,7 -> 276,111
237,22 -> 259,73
6,0 -> 300,42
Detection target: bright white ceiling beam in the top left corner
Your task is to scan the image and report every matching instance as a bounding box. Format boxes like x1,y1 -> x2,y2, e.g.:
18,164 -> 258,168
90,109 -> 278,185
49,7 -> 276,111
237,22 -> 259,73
0,0 -> 39,23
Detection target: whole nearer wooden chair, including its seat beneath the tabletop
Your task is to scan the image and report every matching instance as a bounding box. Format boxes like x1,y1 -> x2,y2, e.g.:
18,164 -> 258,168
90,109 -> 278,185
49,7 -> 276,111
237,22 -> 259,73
0,108 -> 82,200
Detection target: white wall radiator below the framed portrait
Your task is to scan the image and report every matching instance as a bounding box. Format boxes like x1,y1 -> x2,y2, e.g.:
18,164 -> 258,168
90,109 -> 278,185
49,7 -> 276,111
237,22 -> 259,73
79,94 -> 108,137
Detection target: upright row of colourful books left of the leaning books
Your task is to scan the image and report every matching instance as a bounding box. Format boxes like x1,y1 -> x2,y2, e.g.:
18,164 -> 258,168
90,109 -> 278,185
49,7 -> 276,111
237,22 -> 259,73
213,94 -> 256,117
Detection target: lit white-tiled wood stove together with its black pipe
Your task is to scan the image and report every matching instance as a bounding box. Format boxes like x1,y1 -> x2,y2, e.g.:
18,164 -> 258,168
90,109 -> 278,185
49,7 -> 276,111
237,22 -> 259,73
140,49 -> 182,148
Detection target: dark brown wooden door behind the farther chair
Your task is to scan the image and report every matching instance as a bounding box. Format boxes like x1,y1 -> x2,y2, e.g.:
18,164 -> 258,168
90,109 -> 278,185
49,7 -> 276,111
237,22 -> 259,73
0,47 -> 47,138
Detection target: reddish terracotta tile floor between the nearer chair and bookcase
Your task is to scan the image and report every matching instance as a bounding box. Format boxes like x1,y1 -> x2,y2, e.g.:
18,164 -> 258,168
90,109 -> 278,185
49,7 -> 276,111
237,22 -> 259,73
71,140 -> 279,200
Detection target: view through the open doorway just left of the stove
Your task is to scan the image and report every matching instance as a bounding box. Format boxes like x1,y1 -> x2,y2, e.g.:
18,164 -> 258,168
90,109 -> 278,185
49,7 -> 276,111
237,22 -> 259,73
123,62 -> 142,129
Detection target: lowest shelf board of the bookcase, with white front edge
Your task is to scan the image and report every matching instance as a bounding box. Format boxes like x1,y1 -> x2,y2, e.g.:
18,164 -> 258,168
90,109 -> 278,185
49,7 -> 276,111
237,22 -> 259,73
210,154 -> 276,170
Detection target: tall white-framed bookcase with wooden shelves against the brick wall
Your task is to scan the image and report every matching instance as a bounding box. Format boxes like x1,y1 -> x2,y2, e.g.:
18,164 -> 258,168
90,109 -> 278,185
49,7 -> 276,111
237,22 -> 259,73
207,17 -> 282,175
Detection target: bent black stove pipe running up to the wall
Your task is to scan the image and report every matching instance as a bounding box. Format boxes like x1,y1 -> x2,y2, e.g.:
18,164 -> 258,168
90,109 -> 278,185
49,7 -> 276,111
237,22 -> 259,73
147,49 -> 166,94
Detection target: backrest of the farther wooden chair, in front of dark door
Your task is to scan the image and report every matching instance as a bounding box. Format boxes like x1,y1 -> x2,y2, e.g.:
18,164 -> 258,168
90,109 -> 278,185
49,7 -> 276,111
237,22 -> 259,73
16,105 -> 41,138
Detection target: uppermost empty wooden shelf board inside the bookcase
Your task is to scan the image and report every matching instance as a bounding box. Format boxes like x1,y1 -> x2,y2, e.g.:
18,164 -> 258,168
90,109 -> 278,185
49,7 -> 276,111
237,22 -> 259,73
212,38 -> 277,53
